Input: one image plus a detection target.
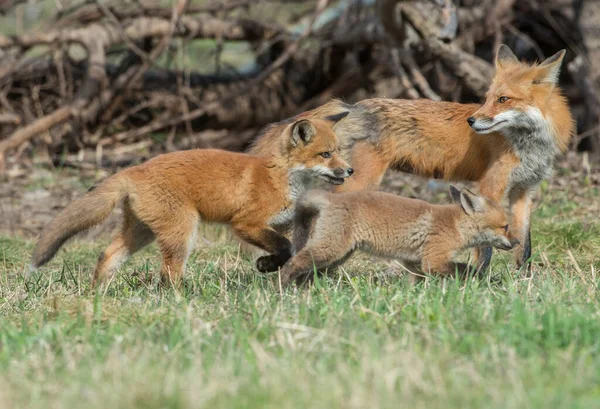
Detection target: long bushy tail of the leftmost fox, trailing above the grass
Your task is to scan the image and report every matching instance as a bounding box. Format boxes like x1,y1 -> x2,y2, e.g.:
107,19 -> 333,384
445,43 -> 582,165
30,175 -> 129,270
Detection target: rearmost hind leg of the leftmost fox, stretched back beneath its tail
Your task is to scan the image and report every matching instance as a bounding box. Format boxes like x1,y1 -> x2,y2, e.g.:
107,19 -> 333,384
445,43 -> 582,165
92,200 -> 154,286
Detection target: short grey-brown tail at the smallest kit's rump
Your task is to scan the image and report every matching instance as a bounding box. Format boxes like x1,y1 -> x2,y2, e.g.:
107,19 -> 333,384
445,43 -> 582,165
292,190 -> 331,253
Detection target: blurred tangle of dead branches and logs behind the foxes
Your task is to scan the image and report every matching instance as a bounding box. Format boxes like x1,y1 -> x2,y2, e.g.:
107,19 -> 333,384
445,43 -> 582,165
0,0 -> 600,231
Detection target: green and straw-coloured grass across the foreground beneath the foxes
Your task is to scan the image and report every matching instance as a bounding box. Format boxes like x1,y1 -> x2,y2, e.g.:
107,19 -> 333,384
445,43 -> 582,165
0,183 -> 600,409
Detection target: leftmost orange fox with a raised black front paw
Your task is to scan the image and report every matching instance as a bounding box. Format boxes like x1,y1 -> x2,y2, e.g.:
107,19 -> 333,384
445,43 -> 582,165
32,113 -> 352,283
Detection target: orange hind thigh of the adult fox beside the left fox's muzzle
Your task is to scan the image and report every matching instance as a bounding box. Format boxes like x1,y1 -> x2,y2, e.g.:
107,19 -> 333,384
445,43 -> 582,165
334,141 -> 390,192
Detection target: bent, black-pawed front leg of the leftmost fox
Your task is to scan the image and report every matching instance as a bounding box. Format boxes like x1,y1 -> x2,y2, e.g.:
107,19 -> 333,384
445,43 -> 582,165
233,224 -> 292,273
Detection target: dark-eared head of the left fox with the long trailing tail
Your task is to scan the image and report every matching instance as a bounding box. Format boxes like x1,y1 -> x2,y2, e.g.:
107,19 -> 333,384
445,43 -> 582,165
284,112 -> 354,185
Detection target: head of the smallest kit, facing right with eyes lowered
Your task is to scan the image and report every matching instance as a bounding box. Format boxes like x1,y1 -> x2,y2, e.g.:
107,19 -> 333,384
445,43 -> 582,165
450,186 -> 519,250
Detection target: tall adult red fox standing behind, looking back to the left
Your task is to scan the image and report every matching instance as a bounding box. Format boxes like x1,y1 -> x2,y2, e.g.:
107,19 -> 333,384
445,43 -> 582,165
248,45 -> 574,269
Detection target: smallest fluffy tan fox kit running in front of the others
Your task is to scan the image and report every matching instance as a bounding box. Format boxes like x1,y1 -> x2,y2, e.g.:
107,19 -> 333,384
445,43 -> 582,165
281,186 -> 518,285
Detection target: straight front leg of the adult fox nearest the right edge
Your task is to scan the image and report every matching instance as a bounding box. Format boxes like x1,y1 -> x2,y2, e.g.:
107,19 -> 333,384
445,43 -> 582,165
509,189 -> 532,271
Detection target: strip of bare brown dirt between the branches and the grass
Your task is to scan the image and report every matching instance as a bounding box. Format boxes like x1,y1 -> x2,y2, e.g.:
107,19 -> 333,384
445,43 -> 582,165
0,154 -> 600,238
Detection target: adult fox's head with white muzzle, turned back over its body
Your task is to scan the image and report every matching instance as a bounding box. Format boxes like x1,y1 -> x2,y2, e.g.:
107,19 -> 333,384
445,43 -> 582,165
467,44 -> 566,135
